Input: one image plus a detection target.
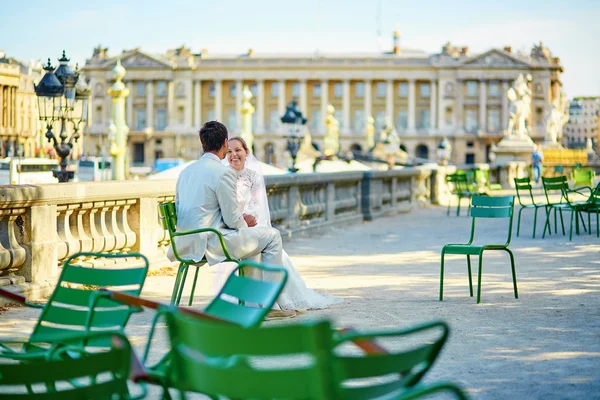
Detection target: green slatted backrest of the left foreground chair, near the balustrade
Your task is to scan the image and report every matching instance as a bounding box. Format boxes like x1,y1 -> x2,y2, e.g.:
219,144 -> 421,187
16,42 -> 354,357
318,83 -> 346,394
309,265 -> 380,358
26,253 -> 148,349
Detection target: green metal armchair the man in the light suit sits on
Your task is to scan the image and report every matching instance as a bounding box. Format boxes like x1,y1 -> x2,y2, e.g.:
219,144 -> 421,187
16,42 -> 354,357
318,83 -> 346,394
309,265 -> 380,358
158,202 -> 243,306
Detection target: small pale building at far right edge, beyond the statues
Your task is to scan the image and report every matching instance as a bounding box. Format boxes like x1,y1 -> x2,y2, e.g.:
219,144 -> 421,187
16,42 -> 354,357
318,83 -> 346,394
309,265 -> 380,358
563,97 -> 600,150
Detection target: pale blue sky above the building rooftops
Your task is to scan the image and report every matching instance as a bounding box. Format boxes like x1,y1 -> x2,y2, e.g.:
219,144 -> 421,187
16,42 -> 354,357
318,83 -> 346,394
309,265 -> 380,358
0,0 -> 600,98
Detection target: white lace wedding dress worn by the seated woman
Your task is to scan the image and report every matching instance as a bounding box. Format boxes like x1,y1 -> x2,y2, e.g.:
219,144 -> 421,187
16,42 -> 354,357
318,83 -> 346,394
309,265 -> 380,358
231,164 -> 342,311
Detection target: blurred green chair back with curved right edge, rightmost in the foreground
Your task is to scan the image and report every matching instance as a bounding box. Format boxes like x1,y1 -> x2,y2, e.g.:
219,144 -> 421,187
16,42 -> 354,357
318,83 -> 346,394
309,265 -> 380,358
334,321 -> 449,400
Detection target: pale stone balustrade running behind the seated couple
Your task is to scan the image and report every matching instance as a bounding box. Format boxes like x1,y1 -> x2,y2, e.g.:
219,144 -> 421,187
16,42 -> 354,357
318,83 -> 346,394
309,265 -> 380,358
0,168 -> 435,298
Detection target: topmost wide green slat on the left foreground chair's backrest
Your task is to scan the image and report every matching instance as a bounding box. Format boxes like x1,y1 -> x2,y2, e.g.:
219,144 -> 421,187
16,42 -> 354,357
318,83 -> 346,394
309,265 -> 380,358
62,265 -> 147,286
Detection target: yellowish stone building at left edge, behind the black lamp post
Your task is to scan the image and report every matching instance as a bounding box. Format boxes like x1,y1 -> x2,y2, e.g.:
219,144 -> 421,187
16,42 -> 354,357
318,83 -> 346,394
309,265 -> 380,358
0,50 -> 42,157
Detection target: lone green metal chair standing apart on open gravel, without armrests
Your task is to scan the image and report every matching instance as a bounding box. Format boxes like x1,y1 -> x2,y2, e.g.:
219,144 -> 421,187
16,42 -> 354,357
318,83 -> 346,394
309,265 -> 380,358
440,196 -> 519,304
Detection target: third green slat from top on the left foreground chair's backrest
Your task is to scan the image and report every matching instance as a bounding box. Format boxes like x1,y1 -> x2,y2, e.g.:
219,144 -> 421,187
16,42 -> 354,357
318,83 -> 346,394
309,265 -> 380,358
39,305 -> 130,327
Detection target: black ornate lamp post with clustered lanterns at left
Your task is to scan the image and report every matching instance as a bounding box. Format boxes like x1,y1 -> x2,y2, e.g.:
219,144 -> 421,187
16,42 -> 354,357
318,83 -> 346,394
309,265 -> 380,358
34,50 -> 91,182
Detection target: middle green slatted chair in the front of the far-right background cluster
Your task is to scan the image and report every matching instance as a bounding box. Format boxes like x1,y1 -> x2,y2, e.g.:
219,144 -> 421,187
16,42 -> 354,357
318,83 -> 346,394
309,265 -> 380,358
542,175 -> 586,240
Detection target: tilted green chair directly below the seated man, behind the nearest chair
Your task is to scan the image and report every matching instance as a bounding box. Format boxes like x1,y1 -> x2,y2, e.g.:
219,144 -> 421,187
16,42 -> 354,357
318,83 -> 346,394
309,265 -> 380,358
142,261 -> 288,392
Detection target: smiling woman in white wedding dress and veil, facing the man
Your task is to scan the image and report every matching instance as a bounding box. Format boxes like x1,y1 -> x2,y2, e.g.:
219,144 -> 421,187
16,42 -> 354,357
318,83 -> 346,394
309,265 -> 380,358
226,137 -> 342,311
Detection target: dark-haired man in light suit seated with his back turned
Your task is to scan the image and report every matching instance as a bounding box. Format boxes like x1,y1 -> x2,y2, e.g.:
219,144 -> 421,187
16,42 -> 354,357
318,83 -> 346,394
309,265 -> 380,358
175,121 -> 283,265
